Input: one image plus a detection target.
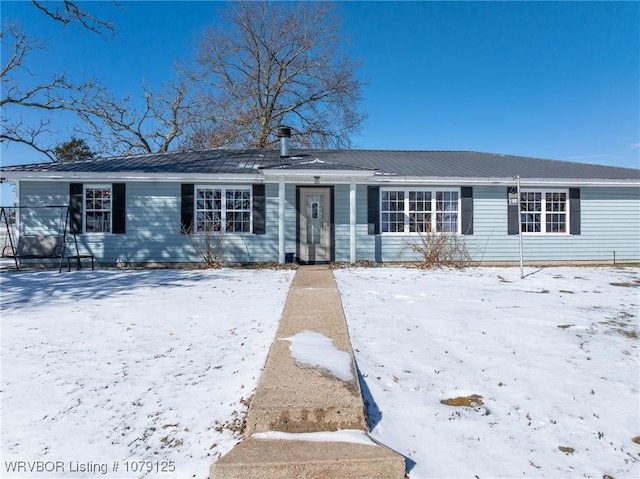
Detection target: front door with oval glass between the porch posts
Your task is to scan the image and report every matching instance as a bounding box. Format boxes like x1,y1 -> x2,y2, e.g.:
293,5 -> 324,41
298,188 -> 332,263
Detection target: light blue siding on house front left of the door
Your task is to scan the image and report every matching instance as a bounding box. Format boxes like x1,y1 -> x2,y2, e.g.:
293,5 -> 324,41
20,181 -> 296,264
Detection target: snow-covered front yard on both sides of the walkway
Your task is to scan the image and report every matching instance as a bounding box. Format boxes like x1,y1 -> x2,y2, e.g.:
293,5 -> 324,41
0,268 -> 640,479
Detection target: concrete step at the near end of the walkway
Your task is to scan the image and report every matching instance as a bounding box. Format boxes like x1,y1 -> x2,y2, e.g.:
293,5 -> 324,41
209,438 -> 405,479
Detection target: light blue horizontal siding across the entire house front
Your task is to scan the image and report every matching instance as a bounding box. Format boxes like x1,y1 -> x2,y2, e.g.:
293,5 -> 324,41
19,181 -> 640,264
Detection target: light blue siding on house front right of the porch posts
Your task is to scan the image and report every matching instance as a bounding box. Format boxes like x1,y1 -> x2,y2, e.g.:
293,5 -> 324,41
366,186 -> 640,262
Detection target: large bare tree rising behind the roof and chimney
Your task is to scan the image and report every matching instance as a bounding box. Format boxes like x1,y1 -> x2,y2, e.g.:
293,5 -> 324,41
192,2 -> 365,147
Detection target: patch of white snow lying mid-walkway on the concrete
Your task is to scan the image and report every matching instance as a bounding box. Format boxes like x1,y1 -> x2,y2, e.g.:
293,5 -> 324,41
280,331 -> 355,382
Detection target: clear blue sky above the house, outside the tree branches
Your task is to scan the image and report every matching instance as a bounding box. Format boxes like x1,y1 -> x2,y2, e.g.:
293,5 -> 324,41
0,0 -> 640,204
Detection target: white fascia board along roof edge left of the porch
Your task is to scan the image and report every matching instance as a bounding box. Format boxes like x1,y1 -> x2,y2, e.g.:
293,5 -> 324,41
2,171 -> 264,183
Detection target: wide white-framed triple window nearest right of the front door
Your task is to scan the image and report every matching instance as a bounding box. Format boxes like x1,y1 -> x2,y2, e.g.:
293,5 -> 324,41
380,188 -> 460,234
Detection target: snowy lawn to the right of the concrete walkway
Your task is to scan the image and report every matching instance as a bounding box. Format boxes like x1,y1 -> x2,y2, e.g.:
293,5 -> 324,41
335,268 -> 640,479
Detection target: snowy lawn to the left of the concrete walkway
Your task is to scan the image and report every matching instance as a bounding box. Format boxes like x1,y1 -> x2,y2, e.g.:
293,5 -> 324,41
0,270 -> 294,479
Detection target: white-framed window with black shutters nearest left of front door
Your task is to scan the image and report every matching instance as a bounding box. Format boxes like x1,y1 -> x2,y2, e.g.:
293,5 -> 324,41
194,186 -> 253,233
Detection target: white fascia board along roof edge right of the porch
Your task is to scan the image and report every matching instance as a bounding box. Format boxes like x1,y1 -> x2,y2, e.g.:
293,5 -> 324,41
371,175 -> 640,187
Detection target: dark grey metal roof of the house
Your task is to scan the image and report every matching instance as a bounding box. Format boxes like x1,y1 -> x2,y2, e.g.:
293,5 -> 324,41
0,148 -> 640,180
